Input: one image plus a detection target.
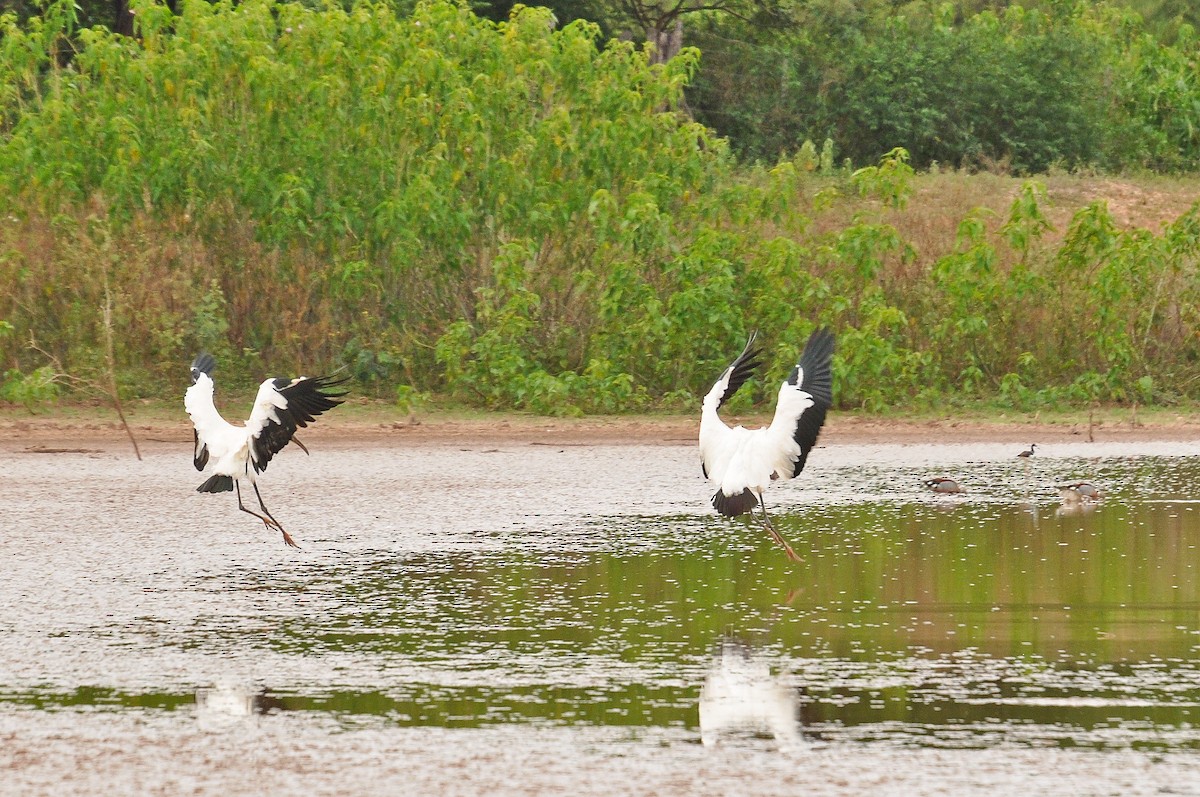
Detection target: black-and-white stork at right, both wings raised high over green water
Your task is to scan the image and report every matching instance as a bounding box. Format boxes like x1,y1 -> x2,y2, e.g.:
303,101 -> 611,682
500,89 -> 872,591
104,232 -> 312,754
700,329 -> 834,561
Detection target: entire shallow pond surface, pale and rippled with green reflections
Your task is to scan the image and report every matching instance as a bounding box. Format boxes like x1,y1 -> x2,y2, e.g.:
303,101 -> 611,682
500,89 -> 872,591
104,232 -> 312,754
0,441 -> 1200,793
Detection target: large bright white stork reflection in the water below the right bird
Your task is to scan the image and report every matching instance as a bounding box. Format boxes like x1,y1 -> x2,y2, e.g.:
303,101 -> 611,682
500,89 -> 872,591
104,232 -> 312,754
700,637 -> 804,750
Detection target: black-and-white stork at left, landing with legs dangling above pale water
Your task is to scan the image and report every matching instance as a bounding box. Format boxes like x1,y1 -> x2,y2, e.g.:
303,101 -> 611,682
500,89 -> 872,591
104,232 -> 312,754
184,354 -> 346,547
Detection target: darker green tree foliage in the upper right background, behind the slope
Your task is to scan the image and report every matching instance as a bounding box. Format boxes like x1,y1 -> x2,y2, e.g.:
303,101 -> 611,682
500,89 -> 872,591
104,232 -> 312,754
689,2 -> 1200,174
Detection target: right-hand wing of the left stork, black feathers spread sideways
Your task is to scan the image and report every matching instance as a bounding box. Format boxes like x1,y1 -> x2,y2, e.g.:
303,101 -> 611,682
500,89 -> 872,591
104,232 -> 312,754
246,376 -> 347,473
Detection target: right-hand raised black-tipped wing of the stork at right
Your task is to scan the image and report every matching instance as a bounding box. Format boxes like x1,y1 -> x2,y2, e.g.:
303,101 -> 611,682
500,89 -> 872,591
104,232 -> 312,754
770,328 -> 834,477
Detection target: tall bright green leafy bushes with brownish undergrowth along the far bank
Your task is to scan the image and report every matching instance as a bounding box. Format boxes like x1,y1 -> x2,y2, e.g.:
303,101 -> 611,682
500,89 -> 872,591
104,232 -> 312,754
0,0 -> 1200,413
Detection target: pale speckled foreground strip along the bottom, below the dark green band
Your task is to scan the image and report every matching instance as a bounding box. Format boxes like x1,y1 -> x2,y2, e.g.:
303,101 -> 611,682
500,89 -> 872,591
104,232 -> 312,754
0,715 -> 1200,797
